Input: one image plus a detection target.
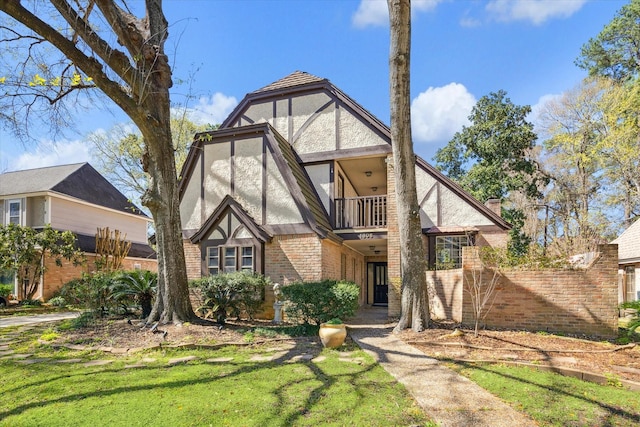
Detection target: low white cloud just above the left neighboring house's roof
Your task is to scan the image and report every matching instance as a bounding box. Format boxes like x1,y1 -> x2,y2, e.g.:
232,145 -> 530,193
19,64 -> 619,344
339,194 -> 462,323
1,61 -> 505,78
11,140 -> 91,170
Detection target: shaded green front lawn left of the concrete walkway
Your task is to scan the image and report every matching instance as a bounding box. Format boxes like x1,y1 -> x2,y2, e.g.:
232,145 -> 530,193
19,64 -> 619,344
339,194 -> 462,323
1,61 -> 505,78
0,327 -> 432,426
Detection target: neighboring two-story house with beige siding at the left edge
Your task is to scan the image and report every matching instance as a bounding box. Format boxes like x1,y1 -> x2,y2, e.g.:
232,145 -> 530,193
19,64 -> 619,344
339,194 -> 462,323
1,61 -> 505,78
0,163 -> 157,300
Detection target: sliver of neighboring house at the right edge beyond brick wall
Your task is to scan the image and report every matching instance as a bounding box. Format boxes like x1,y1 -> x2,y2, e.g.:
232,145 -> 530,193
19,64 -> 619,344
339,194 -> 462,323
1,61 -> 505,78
611,220 -> 640,303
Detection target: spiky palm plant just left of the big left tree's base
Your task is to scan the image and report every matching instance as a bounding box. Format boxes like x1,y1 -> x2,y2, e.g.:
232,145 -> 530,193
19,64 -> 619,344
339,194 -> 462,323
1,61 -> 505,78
111,270 -> 158,319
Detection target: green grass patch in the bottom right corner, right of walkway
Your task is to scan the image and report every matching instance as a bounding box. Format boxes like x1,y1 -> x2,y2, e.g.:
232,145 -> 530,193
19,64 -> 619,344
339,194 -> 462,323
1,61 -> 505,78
451,363 -> 640,426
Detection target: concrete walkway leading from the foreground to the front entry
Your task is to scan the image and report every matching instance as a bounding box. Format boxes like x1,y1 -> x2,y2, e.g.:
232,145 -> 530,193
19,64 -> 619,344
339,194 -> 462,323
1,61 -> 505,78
347,307 -> 536,427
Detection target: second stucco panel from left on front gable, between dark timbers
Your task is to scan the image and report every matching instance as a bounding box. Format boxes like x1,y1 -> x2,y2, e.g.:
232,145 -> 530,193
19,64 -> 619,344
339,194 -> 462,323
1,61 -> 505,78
200,142 -> 231,221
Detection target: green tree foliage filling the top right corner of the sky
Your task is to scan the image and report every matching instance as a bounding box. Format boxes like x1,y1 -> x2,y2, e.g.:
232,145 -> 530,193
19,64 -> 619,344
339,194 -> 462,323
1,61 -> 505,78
576,0 -> 640,80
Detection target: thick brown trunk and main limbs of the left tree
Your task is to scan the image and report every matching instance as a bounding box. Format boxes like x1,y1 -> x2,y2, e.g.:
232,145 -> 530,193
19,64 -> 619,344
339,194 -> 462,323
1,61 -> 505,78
0,0 -> 198,323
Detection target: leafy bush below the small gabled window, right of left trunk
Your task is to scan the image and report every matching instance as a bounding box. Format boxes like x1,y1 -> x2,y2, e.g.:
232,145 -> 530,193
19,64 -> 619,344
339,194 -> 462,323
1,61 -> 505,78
191,271 -> 269,323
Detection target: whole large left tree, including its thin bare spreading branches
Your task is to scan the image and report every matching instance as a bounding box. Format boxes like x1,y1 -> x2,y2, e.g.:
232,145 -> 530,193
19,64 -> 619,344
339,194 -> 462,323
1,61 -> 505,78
0,0 -> 196,323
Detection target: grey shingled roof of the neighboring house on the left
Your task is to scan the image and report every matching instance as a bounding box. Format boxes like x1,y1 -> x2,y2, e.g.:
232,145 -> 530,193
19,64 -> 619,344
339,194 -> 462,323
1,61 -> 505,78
0,162 -> 147,217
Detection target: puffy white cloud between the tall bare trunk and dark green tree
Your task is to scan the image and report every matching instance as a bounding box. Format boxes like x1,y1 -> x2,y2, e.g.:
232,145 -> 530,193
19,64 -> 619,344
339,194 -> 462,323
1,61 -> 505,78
411,83 -> 476,143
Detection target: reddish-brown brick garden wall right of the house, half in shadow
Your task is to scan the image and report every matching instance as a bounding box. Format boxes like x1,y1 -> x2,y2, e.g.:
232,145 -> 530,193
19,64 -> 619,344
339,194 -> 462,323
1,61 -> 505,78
444,245 -> 618,337
